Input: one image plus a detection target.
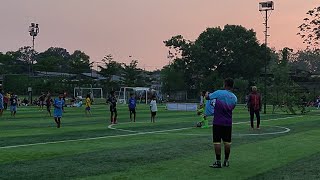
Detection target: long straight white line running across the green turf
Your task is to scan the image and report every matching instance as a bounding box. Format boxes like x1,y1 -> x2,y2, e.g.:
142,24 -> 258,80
0,116 -> 302,149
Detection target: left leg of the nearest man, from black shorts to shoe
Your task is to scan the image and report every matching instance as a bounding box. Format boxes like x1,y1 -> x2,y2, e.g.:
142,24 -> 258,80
210,125 -> 221,168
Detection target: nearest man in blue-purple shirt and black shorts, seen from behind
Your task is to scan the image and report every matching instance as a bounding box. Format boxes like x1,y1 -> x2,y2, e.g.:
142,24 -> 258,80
206,78 -> 237,168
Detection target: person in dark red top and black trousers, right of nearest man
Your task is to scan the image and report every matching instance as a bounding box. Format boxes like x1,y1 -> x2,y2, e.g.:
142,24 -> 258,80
248,86 -> 262,129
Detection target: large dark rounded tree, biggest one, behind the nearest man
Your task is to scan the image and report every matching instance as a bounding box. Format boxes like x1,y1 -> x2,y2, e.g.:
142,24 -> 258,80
164,25 -> 265,94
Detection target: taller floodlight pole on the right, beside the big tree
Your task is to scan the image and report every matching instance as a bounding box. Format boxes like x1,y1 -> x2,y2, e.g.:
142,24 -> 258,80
259,1 -> 274,114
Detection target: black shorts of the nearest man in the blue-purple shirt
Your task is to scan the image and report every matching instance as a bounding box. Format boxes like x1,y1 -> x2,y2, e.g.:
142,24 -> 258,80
212,125 -> 232,144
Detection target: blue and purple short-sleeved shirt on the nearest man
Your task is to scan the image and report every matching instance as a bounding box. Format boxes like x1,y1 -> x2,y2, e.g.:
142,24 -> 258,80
209,90 -> 238,126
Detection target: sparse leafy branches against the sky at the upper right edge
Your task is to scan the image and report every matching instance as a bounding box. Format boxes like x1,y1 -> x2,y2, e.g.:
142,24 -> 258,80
298,6 -> 320,49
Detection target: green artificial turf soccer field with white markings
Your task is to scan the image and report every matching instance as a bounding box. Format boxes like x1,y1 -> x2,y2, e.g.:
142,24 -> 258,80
0,105 -> 320,180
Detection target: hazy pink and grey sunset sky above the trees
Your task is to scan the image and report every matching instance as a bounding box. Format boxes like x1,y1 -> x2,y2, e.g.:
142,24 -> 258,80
0,0 -> 320,70
